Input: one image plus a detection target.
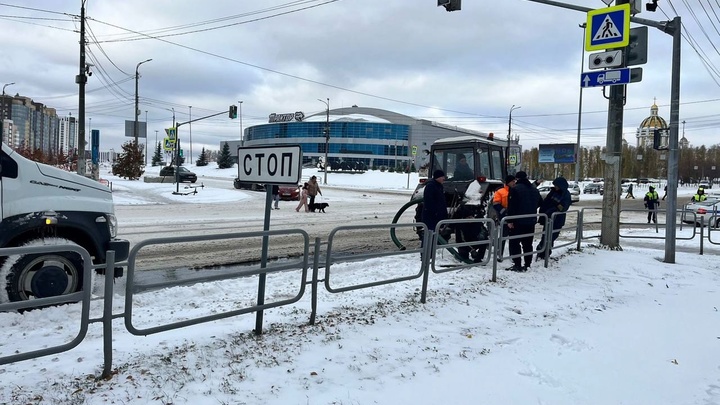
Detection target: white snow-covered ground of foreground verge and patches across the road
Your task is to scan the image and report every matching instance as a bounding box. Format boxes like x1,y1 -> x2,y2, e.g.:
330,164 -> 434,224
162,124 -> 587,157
0,166 -> 720,405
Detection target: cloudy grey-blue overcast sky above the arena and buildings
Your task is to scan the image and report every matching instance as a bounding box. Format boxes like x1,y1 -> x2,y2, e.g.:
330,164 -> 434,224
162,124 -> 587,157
0,0 -> 720,157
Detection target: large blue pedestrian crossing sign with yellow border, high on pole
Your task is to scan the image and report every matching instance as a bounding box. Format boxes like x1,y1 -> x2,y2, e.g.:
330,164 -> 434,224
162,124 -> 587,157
585,4 -> 630,51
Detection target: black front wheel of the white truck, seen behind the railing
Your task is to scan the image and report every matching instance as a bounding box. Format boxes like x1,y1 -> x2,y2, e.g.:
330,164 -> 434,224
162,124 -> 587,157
7,252 -> 83,301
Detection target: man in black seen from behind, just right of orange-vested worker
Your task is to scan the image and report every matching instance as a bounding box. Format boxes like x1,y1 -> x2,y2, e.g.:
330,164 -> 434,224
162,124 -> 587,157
507,171 -> 541,271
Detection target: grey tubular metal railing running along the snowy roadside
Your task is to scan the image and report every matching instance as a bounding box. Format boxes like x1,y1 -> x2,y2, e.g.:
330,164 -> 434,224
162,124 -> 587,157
0,208 -> 720,378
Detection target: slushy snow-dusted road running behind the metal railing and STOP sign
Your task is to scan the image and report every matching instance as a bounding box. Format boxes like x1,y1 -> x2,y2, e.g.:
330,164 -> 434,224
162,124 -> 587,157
116,179 -> 668,270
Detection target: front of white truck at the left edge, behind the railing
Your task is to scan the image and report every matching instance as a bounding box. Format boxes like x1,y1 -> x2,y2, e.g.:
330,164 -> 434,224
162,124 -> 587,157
0,143 -> 130,302
